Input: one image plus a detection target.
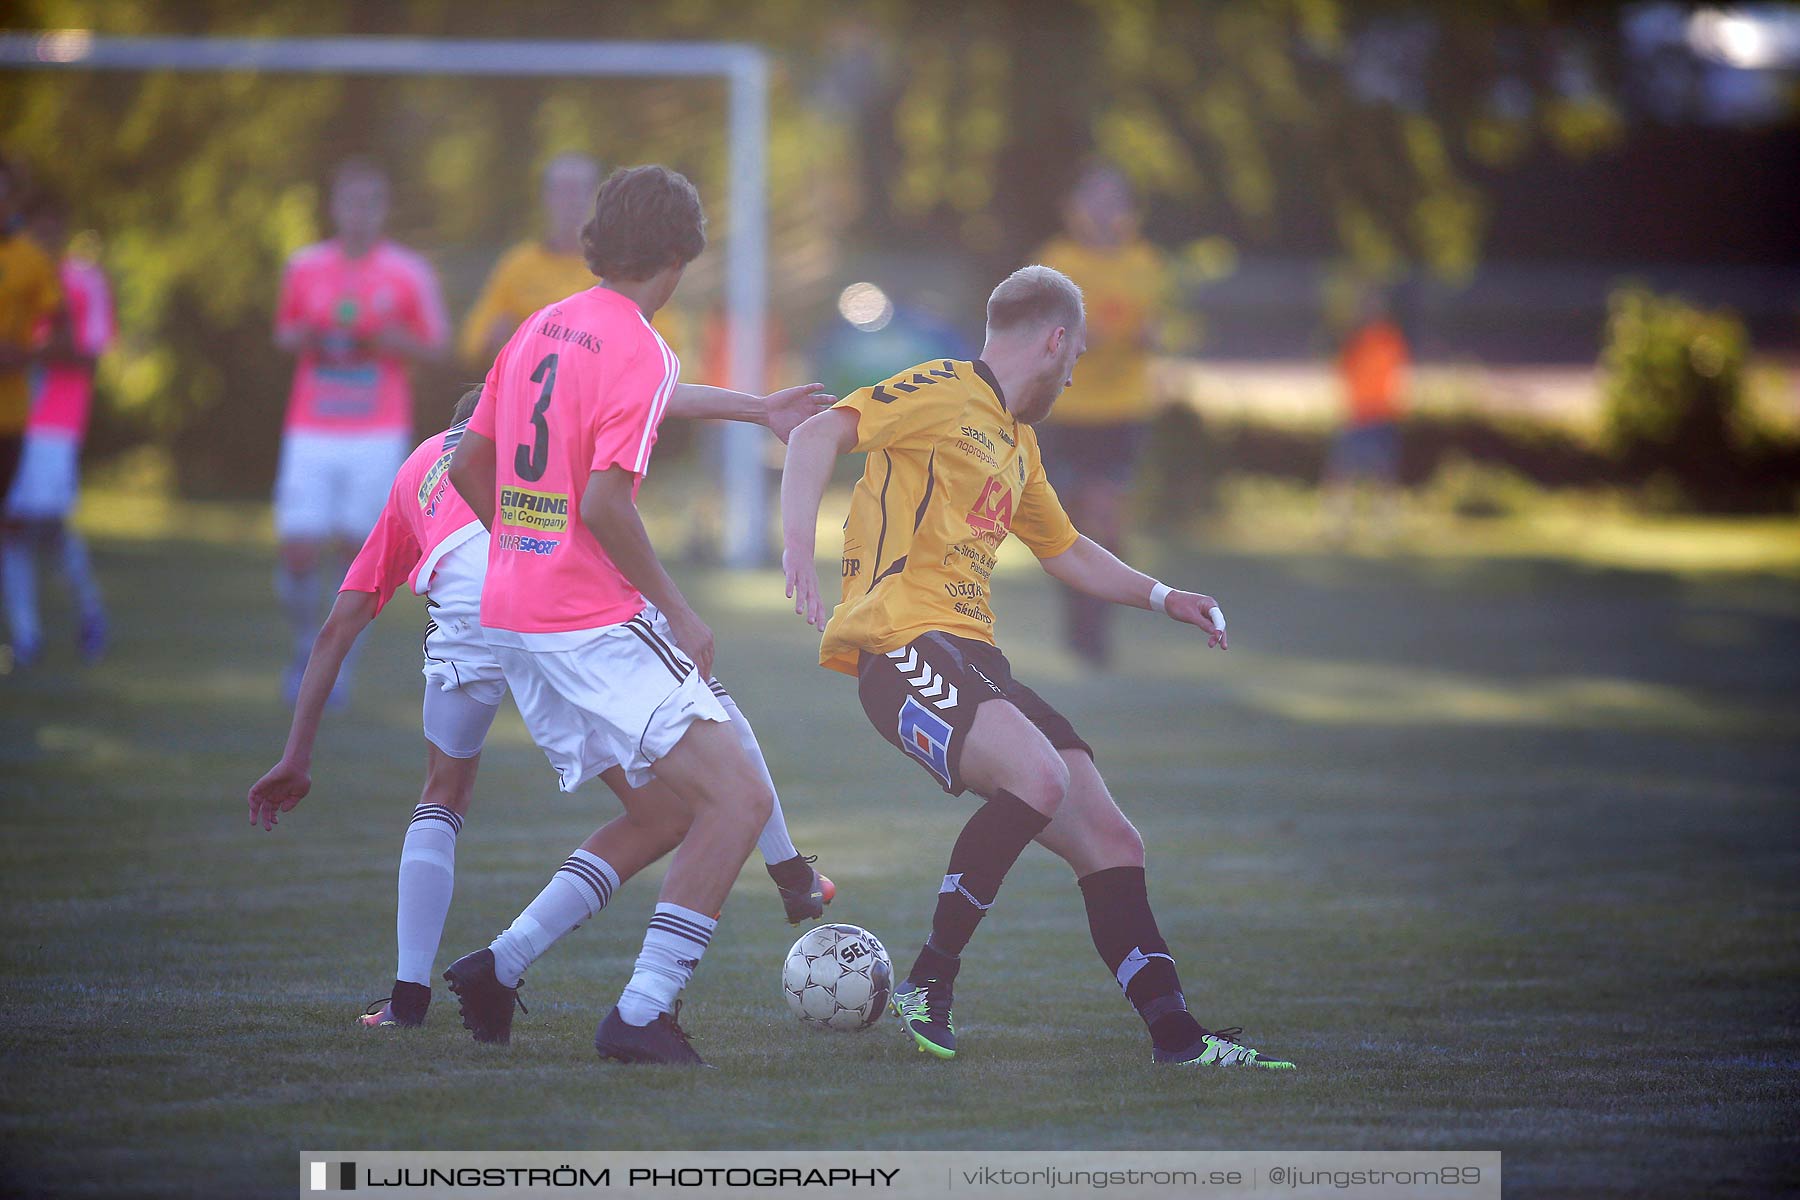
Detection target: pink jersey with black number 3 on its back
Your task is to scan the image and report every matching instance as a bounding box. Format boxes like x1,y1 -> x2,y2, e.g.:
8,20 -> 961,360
468,288 -> 680,633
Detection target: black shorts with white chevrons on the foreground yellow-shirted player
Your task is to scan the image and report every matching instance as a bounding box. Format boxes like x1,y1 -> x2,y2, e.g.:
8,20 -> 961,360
857,631 -> 1094,795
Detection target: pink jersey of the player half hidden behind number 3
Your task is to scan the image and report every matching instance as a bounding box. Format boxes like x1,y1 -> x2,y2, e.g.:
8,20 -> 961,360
338,425 -> 482,612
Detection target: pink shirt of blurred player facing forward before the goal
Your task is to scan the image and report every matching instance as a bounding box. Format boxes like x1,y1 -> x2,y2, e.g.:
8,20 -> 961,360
275,241 -> 450,434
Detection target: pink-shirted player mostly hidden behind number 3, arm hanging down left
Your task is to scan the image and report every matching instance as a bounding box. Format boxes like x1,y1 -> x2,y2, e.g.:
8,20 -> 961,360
248,389 -> 832,1029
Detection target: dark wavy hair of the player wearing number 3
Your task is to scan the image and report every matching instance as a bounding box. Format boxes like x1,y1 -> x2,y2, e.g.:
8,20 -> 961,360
581,166 -> 706,279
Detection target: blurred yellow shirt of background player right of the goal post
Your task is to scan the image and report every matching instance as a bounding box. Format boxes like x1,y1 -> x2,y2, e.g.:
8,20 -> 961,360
1037,237 -> 1168,425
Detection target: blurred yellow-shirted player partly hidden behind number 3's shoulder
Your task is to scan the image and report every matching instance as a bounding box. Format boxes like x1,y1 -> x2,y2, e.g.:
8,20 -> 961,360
457,155 -> 599,372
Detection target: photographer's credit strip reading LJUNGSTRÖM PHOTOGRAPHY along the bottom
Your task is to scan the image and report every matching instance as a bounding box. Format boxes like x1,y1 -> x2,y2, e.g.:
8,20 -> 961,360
301,1150 -> 1499,1200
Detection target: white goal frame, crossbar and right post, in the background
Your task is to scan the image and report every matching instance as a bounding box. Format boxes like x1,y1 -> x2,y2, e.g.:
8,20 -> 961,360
0,29 -> 769,567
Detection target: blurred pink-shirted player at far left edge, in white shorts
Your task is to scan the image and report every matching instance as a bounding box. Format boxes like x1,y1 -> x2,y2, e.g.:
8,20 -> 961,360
0,193 -> 115,667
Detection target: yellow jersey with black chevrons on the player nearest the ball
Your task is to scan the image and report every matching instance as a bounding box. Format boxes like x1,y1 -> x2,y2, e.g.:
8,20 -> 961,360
819,358 -> 1080,675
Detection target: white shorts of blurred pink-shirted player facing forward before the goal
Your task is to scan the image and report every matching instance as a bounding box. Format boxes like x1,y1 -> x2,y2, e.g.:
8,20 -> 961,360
275,430 -> 412,543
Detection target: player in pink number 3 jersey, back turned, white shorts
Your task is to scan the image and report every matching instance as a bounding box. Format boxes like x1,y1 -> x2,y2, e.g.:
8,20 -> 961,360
445,167 -> 824,1065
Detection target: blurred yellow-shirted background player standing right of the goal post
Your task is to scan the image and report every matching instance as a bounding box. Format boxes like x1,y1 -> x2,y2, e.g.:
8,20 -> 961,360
1037,166 -> 1168,667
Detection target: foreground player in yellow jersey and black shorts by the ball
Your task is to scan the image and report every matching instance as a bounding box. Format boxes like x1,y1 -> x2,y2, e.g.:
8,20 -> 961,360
781,266 -> 1292,1067
